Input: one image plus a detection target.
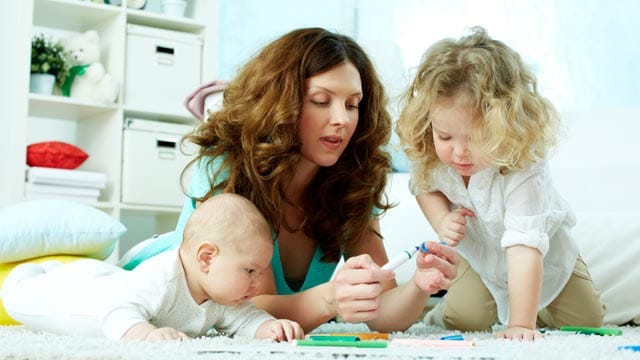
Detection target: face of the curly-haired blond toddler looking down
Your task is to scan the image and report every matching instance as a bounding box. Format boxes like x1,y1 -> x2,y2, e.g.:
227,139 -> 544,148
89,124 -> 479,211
431,101 -> 489,180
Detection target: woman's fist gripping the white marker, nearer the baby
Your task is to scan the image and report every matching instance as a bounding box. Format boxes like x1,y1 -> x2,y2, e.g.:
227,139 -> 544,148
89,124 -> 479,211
333,254 -> 395,322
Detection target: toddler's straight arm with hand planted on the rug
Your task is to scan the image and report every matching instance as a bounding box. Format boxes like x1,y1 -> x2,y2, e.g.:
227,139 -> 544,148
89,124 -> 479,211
498,245 -> 542,340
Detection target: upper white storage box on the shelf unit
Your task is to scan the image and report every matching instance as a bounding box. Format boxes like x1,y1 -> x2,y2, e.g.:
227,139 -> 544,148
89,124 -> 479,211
124,24 -> 203,115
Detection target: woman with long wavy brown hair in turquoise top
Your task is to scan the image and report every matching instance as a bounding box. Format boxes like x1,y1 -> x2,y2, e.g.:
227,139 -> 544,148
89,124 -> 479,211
132,28 -> 458,332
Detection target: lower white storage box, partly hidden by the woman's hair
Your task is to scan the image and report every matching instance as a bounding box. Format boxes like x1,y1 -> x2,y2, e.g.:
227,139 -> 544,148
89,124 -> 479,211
122,119 -> 195,206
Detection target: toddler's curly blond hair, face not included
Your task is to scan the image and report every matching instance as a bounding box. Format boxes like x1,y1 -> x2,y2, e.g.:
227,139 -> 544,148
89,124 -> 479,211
396,27 -> 558,188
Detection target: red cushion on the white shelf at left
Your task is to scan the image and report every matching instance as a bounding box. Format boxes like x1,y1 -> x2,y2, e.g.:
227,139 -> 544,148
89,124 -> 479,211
27,141 -> 89,169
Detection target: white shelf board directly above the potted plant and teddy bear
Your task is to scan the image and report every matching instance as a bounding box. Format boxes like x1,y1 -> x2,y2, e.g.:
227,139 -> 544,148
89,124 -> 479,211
33,0 -> 122,32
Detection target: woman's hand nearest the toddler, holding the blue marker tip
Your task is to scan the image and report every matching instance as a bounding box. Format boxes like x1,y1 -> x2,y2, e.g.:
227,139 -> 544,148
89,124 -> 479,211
413,241 -> 460,295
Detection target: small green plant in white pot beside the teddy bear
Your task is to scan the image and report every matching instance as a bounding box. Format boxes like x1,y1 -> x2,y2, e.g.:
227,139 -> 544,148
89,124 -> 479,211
29,34 -> 68,94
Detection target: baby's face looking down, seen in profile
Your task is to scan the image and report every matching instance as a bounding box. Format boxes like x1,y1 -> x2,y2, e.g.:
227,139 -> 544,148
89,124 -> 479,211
201,238 -> 273,306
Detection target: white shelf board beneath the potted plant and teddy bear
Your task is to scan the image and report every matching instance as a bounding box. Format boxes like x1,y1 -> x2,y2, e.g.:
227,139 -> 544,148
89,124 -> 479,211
29,93 -> 118,120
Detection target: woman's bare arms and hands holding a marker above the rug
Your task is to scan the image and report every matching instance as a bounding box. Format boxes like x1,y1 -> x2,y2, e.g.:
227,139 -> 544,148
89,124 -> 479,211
253,220 -> 458,332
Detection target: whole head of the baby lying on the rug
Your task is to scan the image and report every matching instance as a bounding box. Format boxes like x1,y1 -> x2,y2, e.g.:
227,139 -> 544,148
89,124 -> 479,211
180,193 -> 273,305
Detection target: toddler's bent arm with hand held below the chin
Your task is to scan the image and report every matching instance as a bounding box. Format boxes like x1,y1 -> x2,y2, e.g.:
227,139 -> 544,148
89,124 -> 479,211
416,191 -> 475,246
